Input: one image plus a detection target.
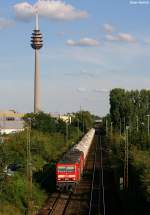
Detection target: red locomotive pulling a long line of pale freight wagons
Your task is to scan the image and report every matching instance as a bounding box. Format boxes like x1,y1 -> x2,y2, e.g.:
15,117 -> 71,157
56,128 -> 95,191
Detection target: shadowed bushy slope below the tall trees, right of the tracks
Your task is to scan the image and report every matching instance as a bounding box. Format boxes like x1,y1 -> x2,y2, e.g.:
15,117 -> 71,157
108,134 -> 150,215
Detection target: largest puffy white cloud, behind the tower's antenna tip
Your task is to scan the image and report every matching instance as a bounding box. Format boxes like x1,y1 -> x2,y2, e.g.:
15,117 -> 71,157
13,0 -> 88,21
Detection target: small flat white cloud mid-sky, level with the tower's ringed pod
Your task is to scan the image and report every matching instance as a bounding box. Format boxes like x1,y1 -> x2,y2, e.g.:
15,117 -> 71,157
66,37 -> 100,46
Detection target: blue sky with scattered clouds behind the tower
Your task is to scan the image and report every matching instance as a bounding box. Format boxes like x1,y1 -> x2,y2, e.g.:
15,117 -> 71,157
0,0 -> 150,116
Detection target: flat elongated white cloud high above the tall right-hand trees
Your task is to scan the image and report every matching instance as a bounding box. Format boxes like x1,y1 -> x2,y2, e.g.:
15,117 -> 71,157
106,33 -> 136,43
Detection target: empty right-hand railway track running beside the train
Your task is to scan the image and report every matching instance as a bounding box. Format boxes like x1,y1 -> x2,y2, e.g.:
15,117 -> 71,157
88,129 -> 124,215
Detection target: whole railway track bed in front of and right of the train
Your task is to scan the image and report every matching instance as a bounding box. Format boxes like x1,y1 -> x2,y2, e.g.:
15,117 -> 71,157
37,128 -> 122,215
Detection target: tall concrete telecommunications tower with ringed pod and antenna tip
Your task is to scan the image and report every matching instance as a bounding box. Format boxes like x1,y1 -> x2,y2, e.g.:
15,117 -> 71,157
31,12 -> 43,113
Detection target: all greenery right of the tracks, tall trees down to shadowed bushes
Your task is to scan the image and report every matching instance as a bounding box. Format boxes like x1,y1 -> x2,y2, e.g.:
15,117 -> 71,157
105,89 -> 150,215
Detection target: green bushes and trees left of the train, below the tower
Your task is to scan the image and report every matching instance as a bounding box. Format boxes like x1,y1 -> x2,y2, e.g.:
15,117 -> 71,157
0,112 -> 92,215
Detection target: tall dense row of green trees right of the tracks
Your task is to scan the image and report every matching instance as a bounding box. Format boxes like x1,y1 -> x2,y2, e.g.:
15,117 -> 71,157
110,89 -> 150,135
